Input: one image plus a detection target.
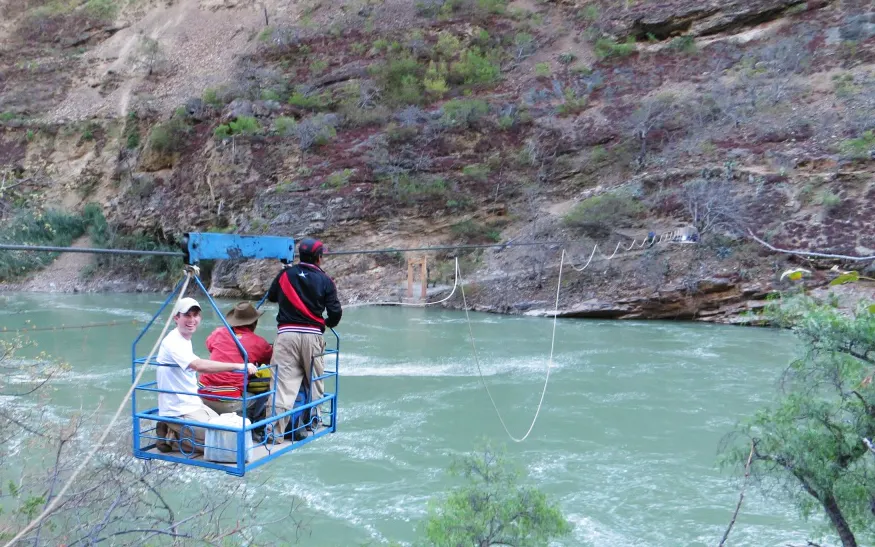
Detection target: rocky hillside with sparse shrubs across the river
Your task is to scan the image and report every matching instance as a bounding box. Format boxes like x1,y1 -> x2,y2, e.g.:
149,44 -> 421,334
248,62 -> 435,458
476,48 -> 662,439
0,0 -> 875,321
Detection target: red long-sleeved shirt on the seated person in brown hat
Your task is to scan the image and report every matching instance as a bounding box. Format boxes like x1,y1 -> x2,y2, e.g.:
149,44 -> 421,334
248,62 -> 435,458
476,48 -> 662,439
198,327 -> 273,397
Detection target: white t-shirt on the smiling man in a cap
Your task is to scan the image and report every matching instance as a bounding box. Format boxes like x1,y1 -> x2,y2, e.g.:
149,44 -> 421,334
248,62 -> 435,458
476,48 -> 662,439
155,329 -> 204,416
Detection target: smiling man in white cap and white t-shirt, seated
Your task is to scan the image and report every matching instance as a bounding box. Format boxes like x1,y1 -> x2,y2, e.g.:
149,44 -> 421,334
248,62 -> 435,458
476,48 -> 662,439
155,297 -> 258,453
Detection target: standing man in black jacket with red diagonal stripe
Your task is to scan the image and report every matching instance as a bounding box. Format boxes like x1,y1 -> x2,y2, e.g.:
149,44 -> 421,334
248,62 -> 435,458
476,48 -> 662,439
267,238 -> 343,442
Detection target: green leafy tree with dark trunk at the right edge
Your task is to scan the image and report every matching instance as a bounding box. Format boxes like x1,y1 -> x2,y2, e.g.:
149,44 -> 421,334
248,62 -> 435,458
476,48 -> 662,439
729,297 -> 875,547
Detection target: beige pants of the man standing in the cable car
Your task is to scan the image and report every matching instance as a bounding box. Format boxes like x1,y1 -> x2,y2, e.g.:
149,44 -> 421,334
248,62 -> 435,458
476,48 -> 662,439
268,332 -> 325,433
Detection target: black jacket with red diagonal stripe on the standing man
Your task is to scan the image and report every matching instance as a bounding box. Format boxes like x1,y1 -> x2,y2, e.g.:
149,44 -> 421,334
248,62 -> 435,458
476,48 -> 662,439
267,262 -> 343,332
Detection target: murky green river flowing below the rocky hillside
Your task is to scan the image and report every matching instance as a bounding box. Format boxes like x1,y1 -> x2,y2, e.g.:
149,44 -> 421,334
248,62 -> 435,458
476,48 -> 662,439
0,293 -> 810,547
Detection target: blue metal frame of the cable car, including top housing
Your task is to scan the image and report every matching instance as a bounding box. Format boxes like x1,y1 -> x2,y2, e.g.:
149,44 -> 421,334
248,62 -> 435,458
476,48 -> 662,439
131,233 -> 340,477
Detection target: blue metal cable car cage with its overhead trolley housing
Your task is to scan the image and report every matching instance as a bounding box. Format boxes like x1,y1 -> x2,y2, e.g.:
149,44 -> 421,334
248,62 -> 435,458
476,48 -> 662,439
131,233 -> 340,477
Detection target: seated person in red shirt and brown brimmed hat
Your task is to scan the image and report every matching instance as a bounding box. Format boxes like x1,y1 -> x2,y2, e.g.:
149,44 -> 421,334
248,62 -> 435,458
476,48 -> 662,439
198,302 -> 273,422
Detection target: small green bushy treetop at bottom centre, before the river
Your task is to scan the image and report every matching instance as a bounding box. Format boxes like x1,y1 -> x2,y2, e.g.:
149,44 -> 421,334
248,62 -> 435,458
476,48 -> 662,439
422,444 -> 571,547
